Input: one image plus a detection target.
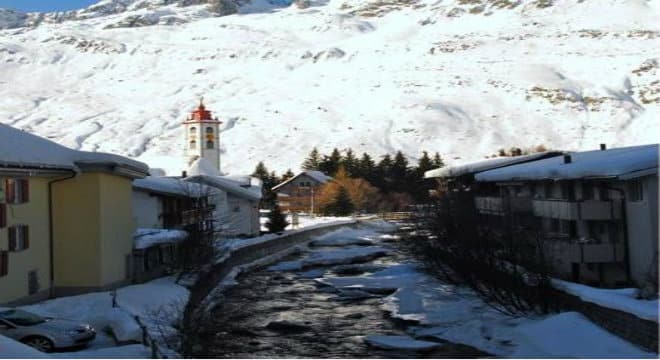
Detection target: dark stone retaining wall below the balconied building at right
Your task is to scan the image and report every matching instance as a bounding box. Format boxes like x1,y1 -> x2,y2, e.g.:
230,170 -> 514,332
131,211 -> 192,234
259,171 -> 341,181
557,291 -> 658,353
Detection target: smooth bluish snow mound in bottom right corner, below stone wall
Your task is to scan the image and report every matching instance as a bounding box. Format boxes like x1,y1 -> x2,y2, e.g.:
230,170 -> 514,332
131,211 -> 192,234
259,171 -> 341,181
511,312 -> 657,359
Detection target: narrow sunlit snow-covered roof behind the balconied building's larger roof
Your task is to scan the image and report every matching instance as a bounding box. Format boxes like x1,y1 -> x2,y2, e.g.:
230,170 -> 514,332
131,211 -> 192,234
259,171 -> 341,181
424,151 -> 561,179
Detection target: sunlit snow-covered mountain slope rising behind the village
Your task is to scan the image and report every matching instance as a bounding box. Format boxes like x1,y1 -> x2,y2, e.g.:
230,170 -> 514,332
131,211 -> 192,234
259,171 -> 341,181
0,0 -> 660,173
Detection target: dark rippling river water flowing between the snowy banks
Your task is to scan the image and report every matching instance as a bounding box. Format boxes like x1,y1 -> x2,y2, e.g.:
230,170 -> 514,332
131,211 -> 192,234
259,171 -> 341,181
208,222 -> 488,358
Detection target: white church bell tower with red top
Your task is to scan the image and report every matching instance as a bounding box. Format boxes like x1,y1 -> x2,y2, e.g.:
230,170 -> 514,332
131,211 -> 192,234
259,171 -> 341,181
183,98 -> 222,172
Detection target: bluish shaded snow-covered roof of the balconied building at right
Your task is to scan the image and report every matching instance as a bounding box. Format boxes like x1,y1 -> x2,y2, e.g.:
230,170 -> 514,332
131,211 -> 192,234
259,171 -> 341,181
475,144 -> 658,181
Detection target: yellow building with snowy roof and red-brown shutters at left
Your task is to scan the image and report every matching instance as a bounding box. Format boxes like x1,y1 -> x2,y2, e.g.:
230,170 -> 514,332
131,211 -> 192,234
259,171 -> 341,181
0,124 -> 148,304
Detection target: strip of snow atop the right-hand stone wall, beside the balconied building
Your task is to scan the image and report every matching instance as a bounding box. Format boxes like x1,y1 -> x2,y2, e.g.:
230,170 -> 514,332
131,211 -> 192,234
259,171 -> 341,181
552,279 -> 660,322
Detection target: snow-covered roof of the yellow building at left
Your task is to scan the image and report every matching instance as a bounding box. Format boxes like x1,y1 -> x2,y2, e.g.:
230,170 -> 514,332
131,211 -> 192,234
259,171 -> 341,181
0,124 -> 149,175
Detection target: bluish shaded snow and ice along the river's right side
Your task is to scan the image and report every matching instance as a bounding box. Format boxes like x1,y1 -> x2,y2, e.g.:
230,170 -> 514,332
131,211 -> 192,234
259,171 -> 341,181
269,228 -> 658,358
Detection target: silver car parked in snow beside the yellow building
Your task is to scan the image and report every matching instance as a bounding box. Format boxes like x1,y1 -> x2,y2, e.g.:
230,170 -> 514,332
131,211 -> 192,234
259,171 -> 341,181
0,308 -> 96,352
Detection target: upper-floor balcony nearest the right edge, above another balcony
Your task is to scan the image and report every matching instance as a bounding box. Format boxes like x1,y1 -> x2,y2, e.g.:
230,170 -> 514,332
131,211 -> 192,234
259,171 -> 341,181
532,200 -> 621,220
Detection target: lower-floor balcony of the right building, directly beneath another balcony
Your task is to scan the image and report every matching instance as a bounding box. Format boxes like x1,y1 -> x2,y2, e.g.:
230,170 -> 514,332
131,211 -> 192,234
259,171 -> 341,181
545,240 -> 625,264
